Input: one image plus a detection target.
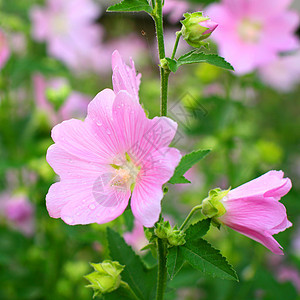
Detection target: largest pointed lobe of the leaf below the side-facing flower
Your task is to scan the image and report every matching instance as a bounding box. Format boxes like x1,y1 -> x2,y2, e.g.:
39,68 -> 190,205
181,238 -> 238,281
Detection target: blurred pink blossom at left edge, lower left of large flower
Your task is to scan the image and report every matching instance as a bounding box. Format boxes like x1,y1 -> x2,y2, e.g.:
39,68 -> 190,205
0,194 -> 35,236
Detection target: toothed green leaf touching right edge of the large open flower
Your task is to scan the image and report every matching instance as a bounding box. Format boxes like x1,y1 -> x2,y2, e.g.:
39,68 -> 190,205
169,150 -> 210,184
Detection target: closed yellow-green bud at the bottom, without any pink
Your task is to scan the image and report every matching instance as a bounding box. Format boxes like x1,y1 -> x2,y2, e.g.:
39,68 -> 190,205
85,260 -> 125,296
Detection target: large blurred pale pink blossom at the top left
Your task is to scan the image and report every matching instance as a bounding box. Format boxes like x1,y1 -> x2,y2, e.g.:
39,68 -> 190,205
30,0 -> 103,71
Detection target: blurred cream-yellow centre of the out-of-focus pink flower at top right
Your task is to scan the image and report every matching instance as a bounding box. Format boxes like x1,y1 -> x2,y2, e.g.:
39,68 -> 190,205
238,19 -> 262,44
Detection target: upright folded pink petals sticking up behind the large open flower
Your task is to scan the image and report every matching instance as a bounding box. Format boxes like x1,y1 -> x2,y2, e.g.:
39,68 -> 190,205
112,50 -> 141,102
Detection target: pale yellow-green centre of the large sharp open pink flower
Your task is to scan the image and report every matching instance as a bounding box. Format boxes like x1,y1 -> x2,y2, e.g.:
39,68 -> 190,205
110,153 -> 141,191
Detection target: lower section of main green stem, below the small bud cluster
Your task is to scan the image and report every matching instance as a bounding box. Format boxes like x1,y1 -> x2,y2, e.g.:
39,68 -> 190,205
156,238 -> 167,300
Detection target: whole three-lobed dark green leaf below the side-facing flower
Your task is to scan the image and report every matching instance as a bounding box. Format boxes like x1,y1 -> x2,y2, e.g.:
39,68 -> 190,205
167,219 -> 238,280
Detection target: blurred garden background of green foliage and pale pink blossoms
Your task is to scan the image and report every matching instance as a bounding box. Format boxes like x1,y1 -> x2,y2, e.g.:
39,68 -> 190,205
0,0 -> 300,300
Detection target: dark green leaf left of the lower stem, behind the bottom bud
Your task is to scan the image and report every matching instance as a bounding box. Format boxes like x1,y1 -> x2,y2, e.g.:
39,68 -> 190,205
107,227 -> 157,300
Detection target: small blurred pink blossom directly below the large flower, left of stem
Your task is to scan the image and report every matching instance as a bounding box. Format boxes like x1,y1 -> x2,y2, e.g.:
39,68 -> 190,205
123,219 -> 148,252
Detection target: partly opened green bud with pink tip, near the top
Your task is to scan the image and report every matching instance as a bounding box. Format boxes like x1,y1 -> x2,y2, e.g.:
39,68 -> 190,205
181,12 -> 218,48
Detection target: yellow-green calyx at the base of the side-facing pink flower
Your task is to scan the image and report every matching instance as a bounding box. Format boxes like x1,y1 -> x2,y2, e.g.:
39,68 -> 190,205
201,188 -> 230,220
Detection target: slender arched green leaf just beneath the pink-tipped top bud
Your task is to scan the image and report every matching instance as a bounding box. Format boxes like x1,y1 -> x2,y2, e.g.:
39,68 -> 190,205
167,50 -> 234,73
